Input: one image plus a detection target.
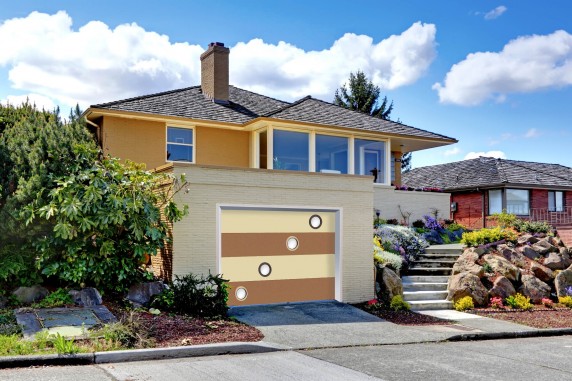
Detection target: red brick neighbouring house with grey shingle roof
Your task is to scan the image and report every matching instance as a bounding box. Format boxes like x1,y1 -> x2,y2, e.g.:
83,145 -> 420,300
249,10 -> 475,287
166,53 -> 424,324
403,157 -> 572,243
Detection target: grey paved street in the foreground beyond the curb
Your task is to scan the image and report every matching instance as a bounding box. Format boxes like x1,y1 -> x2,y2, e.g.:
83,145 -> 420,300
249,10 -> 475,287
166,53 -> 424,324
0,336 -> 572,381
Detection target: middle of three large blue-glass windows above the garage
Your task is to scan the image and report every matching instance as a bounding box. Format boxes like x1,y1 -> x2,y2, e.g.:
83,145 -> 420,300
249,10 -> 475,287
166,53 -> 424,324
316,134 -> 348,173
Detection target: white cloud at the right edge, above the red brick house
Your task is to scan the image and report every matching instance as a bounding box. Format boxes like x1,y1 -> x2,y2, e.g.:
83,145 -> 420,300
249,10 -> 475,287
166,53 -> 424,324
433,30 -> 572,106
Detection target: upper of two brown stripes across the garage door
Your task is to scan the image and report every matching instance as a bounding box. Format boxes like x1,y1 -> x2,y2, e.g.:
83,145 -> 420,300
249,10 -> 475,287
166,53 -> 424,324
221,233 -> 336,257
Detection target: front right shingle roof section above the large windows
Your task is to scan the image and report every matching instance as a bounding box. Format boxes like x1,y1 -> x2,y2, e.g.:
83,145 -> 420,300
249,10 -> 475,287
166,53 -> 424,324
266,96 -> 456,142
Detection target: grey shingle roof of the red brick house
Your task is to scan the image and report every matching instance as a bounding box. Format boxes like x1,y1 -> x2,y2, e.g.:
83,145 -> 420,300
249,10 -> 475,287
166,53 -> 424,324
402,157 -> 572,190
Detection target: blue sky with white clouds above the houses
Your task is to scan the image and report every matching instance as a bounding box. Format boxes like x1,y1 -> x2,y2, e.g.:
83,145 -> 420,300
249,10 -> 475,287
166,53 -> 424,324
0,0 -> 572,167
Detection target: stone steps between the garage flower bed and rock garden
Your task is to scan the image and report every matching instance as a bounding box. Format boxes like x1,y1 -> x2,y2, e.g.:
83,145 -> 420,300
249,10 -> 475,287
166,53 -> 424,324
402,244 -> 463,310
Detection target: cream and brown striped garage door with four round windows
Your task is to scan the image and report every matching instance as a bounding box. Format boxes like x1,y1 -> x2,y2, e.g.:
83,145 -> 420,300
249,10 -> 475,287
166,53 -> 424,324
219,207 -> 340,306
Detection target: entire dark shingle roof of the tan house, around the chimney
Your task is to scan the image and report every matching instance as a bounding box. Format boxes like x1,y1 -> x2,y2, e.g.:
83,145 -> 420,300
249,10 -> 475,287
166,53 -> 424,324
91,86 -> 456,143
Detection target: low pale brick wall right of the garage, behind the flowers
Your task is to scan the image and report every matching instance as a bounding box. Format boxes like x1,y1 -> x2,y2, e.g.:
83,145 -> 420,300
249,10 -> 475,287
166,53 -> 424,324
373,185 -> 451,223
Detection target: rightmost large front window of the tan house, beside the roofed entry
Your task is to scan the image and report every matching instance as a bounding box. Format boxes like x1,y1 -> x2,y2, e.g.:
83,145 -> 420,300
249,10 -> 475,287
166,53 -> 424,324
354,139 -> 386,184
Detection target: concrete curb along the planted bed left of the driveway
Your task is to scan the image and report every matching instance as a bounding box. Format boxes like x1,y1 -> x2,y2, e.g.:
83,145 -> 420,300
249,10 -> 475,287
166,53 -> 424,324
0,341 -> 291,369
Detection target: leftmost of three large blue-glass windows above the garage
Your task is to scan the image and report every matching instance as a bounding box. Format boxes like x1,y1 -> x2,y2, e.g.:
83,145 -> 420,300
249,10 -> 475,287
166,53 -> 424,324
273,130 -> 310,171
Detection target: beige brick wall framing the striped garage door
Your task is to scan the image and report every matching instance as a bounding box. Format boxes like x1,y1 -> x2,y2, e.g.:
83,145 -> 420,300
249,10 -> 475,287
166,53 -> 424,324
173,164 -> 374,302
